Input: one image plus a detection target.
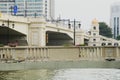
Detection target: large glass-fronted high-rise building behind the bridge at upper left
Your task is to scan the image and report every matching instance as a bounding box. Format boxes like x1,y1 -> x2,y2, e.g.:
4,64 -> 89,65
0,0 -> 54,19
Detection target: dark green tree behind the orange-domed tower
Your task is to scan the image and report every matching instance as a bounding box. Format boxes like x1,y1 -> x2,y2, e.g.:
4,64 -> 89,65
99,22 -> 112,38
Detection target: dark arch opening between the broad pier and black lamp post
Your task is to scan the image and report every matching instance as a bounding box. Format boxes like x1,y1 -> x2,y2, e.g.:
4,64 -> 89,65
46,31 -> 73,46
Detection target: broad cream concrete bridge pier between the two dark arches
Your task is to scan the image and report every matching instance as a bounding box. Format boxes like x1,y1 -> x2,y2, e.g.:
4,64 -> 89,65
28,23 -> 46,46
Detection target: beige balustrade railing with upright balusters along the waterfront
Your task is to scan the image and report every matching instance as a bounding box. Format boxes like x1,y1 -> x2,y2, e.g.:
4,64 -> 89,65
0,47 -> 120,62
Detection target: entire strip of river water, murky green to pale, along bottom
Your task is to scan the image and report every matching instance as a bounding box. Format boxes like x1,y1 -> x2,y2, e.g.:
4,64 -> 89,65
0,68 -> 120,80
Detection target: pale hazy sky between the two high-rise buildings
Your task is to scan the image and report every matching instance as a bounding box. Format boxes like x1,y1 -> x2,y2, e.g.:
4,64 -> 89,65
55,0 -> 120,29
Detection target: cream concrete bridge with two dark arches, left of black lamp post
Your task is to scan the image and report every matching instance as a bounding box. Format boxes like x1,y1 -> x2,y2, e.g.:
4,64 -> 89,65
0,14 -> 80,46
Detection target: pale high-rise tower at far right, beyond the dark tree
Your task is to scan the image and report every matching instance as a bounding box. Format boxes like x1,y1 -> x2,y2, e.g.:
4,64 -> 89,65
110,2 -> 120,38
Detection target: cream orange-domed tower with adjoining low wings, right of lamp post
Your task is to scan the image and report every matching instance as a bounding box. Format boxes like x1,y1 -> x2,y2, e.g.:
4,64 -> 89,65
76,19 -> 120,46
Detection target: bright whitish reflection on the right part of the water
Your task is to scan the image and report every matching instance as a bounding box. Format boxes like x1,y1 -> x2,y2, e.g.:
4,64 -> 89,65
53,69 -> 120,80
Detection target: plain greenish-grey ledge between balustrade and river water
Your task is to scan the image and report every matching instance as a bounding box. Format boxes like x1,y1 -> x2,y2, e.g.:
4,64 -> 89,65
0,60 -> 120,71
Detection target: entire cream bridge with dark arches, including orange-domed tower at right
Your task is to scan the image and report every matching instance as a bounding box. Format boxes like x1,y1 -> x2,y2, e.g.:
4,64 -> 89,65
0,14 -> 120,47
